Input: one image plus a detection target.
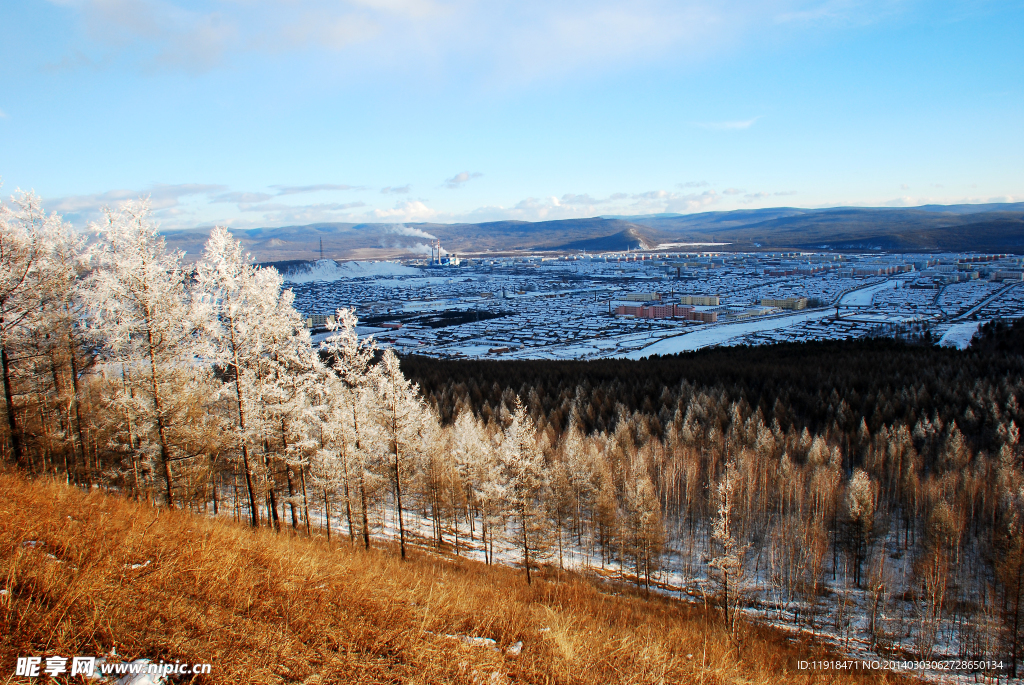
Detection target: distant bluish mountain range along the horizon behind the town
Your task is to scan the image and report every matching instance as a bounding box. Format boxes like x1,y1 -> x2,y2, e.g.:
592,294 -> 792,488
157,203 -> 1024,261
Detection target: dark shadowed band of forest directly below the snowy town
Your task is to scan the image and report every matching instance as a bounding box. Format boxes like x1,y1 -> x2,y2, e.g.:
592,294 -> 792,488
402,319 -> 1024,456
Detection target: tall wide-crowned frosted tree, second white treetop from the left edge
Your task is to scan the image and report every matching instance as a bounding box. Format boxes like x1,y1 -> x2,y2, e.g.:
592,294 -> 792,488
88,201 -> 202,506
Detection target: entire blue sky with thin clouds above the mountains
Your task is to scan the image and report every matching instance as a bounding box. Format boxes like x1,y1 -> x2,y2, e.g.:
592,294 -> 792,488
0,0 -> 1024,228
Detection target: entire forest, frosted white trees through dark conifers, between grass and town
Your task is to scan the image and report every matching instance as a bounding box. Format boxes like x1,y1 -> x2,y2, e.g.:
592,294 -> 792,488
0,195 -> 1024,672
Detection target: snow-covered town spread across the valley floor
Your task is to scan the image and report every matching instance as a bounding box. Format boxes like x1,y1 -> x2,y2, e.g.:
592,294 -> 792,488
285,252 -> 1024,359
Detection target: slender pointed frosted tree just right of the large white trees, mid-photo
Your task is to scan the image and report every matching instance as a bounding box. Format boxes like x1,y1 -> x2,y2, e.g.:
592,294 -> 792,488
499,396 -> 546,583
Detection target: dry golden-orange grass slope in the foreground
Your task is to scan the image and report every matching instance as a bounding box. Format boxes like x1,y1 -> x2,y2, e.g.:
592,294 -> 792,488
0,473 -> 904,685
